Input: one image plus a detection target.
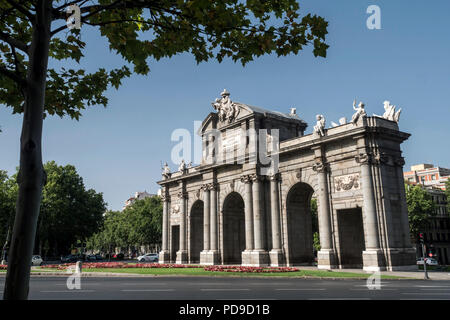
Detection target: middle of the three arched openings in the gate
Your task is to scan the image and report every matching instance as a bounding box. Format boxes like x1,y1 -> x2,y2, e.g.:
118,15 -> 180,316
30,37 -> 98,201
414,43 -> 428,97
223,192 -> 245,264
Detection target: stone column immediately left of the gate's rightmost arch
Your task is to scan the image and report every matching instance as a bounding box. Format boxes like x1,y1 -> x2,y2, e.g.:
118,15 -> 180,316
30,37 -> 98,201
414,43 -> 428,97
269,173 -> 285,267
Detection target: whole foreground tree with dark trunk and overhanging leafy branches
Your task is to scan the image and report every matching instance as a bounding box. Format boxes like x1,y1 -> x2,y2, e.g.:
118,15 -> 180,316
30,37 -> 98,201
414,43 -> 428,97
0,0 -> 328,299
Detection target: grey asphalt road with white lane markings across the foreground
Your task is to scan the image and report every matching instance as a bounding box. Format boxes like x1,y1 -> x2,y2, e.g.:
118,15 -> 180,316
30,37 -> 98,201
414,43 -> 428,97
0,276 -> 450,300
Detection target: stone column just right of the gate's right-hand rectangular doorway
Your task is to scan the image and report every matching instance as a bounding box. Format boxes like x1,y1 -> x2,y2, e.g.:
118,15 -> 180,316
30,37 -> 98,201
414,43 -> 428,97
355,151 -> 384,271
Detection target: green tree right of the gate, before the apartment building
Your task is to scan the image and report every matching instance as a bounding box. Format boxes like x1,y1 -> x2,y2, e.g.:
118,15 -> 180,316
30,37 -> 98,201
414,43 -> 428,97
405,183 -> 436,241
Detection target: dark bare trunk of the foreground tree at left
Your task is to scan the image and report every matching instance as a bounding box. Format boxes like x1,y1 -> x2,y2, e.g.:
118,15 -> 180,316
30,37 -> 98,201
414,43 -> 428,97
3,0 -> 52,300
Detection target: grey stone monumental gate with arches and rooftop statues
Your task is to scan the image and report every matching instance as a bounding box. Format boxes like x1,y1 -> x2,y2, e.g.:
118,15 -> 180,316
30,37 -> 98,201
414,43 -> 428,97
158,90 -> 417,271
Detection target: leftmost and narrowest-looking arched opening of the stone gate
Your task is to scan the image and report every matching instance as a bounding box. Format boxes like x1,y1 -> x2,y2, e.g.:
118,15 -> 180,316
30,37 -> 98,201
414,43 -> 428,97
189,200 -> 204,263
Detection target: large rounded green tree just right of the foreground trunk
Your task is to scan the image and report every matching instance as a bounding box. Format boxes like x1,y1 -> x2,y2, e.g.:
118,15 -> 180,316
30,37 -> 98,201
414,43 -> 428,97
36,161 -> 106,255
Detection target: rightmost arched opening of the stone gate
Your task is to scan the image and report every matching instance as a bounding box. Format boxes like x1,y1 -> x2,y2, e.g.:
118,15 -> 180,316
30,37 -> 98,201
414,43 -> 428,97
286,182 -> 314,265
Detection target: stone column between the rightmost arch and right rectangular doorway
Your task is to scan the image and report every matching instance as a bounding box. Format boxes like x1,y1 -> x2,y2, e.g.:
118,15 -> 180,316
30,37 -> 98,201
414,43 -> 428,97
313,157 -> 336,269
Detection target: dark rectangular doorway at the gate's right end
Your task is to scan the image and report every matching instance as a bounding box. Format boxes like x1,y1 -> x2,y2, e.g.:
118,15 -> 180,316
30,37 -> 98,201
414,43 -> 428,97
337,208 -> 365,268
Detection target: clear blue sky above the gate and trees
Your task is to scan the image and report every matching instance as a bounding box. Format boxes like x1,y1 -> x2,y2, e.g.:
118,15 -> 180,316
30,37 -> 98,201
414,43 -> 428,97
0,0 -> 450,210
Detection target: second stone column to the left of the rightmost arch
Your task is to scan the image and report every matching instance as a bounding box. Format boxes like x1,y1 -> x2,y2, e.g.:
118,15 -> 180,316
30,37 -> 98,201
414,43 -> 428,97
251,175 -> 269,266
